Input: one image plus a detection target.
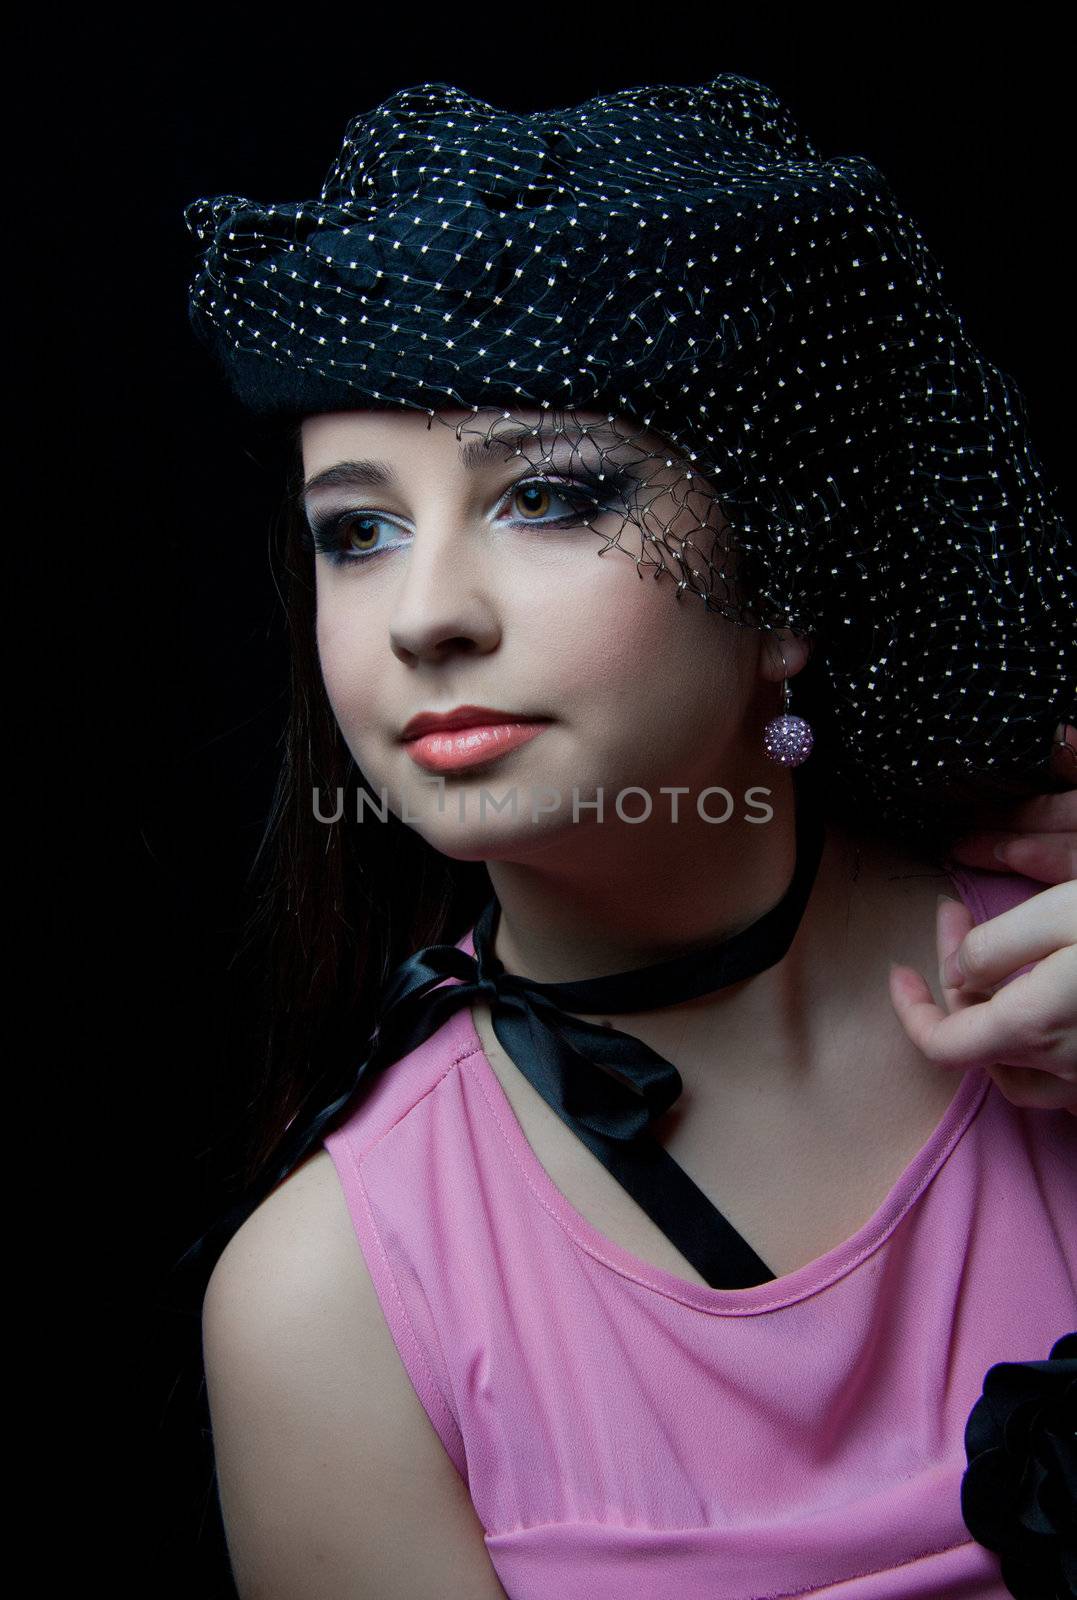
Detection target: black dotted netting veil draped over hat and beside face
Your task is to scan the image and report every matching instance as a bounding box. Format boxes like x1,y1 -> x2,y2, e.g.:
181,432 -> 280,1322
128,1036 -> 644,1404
184,74 -> 1077,830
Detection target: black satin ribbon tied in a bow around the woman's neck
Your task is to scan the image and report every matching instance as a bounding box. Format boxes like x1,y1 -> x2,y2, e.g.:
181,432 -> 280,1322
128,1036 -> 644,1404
184,770 -> 824,1288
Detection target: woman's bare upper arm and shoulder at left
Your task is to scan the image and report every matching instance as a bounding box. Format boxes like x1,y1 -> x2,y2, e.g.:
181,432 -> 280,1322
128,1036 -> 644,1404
203,1150 -> 506,1600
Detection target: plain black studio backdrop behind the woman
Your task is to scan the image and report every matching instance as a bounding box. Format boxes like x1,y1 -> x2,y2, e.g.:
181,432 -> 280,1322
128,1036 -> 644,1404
37,15 -> 1074,1600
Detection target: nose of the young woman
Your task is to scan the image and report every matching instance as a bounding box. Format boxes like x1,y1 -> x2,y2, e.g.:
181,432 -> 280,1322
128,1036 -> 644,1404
389,514 -> 501,664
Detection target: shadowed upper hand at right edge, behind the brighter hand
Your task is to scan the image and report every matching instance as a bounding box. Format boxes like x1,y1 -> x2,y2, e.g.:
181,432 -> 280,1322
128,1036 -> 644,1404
951,723 -> 1077,883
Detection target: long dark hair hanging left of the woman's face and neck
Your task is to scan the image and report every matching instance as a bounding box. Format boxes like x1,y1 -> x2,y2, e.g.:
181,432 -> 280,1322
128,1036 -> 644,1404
228,422 -> 491,1186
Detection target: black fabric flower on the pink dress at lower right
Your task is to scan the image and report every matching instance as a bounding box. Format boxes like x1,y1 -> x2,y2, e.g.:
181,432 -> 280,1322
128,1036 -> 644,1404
962,1333 -> 1077,1600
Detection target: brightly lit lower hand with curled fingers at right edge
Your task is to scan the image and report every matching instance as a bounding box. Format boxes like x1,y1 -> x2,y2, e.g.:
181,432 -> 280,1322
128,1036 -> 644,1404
890,876 -> 1077,1117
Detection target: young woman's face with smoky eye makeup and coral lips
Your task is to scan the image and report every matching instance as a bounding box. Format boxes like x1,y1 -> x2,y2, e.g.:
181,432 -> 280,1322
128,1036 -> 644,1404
302,411 -> 789,861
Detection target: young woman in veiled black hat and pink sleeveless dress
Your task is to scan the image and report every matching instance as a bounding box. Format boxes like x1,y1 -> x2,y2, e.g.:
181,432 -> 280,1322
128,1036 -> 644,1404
180,75 -> 1077,1597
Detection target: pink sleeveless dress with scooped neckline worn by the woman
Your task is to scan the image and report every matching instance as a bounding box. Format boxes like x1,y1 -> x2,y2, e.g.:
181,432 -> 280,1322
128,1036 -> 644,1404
325,864 -> 1077,1600
